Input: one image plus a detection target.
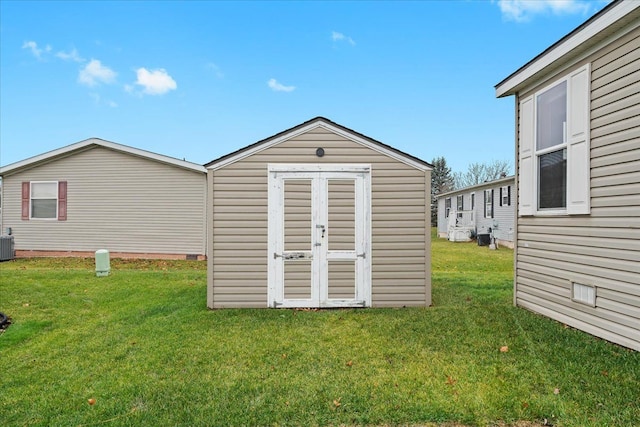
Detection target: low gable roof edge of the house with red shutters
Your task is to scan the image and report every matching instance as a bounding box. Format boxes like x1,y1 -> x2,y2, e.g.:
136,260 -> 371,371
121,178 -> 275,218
0,138 -> 206,176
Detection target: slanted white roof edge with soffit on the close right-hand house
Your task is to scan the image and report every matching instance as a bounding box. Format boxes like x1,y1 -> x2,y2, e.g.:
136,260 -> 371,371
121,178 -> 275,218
495,0 -> 640,98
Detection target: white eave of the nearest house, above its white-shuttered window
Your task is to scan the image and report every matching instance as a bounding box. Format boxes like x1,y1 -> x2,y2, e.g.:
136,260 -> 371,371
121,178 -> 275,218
494,0 -> 640,98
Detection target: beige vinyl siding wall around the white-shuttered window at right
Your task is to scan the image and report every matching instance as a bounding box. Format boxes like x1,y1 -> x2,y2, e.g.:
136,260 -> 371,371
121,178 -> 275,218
516,28 -> 640,350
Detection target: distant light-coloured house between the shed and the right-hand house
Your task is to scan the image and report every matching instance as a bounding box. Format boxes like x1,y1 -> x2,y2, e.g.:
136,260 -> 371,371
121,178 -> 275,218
437,176 -> 515,248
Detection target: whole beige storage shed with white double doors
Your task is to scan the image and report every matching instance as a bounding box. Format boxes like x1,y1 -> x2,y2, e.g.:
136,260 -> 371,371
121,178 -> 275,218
205,117 -> 432,308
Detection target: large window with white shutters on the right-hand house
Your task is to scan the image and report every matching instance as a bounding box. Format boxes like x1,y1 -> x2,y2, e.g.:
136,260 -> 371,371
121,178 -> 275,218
518,64 -> 591,215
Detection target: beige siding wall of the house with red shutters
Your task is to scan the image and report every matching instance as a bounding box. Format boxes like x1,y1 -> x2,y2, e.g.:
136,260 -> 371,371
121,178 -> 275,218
4,147 -> 206,255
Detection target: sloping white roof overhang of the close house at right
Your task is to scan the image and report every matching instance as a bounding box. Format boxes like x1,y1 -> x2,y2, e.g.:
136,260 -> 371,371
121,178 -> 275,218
495,0 -> 640,98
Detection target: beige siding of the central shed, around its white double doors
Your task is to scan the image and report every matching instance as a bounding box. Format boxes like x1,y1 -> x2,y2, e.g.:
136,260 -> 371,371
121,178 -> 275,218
209,127 -> 430,308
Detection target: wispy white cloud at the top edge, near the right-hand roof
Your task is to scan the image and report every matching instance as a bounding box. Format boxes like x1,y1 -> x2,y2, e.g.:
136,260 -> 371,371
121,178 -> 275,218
498,0 -> 592,22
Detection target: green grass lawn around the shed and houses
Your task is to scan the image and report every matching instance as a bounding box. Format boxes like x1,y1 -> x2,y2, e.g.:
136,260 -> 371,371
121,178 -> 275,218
0,232 -> 640,426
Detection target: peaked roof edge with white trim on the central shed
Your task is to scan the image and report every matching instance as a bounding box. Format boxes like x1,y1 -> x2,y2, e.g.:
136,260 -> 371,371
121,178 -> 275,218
205,117 -> 433,170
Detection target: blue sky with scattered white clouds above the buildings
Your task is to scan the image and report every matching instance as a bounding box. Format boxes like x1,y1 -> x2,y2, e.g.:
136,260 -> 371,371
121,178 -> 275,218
0,0 -> 607,172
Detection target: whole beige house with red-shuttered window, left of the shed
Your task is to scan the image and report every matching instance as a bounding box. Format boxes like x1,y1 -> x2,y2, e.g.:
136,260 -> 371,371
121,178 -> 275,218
0,138 -> 206,259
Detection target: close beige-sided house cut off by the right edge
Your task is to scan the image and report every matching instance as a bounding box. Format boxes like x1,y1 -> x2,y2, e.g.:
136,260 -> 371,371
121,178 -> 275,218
496,1 -> 640,350
